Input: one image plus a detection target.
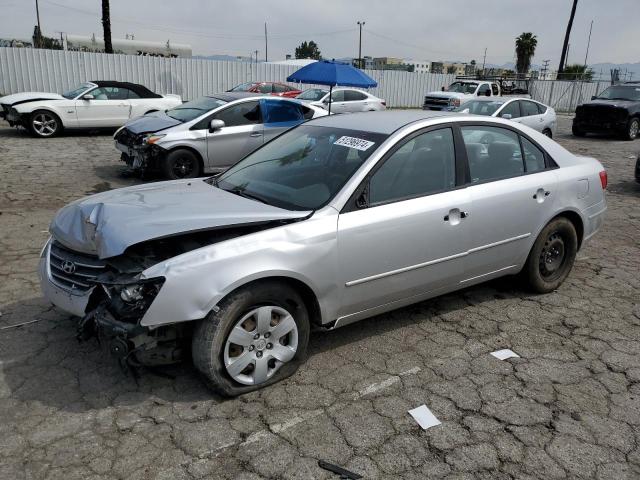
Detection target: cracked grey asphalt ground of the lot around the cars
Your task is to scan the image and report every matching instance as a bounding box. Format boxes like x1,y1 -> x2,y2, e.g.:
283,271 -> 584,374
0,117 -> 640,480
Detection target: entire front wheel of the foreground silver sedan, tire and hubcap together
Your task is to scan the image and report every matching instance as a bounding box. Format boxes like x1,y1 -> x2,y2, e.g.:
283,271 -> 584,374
191,281 -> 310,397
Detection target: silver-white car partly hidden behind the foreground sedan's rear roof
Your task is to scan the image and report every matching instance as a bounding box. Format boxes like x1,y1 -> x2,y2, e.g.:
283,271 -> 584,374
454,97 -> 557,137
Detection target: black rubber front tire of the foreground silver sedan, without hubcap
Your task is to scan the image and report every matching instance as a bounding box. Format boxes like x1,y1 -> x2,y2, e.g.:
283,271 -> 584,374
191,281 -> 310,397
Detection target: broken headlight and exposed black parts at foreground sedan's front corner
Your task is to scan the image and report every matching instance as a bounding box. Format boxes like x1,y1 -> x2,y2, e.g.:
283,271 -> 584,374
78,273 -> 189,370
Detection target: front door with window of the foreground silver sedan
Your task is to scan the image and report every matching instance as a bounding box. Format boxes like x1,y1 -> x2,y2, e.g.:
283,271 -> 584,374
338,128 -> 469,316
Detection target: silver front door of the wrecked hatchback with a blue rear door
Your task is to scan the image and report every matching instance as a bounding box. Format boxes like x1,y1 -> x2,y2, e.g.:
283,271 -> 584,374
207,100 -> 263,170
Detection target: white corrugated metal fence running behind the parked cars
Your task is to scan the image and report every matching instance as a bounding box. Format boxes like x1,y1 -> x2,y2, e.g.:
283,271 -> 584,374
0,47 -> 607,112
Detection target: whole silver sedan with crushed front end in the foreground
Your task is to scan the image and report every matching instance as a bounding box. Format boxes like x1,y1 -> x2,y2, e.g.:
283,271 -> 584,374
40,111 -> 607,395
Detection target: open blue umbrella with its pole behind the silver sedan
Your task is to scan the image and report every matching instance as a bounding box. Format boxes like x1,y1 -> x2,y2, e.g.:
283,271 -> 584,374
287,60 -> 378,114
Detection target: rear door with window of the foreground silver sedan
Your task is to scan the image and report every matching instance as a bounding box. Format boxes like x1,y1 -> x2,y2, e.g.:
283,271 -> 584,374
461,124 -> 557,283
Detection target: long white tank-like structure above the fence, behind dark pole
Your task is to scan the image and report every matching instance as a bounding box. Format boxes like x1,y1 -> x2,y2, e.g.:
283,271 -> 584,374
63,34 -> 191,58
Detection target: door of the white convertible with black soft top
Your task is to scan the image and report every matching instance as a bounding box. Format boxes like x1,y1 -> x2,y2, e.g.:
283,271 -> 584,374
75,87 -> 131,128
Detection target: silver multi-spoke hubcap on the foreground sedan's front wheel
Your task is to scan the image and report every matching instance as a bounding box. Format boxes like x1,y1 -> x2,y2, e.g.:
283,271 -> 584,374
223,305 -> 298,385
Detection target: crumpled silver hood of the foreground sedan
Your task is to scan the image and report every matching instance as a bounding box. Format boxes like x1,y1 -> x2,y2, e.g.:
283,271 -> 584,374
49,179 -> 311,258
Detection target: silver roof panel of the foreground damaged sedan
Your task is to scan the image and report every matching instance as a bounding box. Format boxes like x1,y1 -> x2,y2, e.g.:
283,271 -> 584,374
307,110 -> 459,134
